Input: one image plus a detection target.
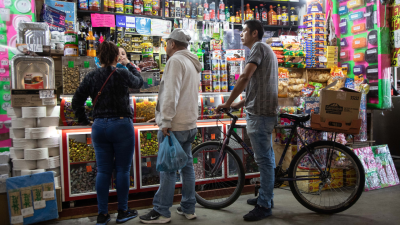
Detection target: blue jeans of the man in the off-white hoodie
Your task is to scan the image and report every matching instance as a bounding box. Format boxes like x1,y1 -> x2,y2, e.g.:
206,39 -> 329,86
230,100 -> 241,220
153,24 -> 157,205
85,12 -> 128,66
153,128 -> 197,218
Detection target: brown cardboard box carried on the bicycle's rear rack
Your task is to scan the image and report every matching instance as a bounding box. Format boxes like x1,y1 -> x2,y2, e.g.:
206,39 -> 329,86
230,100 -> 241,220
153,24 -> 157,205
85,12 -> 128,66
320,85 -> 361,123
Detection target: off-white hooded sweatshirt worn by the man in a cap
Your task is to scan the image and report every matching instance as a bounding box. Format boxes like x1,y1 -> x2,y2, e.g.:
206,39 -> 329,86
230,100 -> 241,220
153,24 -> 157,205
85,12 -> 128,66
156,49 -> 202,131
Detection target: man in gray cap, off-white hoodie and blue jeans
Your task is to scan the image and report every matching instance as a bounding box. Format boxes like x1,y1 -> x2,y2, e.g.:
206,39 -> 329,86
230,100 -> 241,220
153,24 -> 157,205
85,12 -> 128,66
140,29 -> 202,223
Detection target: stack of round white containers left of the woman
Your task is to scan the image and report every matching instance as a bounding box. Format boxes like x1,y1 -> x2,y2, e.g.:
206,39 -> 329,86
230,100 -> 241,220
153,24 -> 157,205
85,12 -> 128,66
7,106 -> 60,187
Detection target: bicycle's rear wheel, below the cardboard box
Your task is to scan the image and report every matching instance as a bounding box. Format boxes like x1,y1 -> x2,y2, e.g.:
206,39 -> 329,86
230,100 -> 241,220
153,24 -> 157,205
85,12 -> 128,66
289,141 -> 365,214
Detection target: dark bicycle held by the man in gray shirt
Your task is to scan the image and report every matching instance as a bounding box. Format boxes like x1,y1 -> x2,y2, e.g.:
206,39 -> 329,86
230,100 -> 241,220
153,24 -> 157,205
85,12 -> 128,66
192,110 -> 365,214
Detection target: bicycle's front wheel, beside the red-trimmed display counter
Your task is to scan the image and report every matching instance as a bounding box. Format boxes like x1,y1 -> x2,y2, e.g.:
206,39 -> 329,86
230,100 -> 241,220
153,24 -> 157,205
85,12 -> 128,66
192,142 -> 245,209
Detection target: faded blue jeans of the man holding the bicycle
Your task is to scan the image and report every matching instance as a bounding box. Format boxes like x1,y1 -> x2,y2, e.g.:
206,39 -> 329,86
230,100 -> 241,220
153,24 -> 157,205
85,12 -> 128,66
246,113 -> 277,208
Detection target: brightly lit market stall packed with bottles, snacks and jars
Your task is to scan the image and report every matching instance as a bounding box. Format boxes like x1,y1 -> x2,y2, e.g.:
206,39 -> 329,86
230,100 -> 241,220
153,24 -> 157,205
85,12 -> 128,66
0,0 -> 398,223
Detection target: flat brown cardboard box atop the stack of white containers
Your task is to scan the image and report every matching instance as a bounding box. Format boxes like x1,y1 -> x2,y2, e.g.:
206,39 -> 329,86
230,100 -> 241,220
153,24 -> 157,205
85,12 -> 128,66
11,89 -> 57,107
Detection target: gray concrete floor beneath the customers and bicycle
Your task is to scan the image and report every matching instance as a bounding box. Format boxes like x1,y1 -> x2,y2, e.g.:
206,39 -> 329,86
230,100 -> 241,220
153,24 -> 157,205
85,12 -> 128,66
40,185 -> 400,225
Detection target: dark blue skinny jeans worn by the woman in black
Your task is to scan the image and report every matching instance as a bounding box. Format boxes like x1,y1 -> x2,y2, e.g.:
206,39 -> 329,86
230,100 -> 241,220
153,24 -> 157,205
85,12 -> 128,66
92,117 -> 135,214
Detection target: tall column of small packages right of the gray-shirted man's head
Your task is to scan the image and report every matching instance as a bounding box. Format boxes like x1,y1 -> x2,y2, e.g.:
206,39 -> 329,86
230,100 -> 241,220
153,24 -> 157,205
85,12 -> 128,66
303,13 -> 327,68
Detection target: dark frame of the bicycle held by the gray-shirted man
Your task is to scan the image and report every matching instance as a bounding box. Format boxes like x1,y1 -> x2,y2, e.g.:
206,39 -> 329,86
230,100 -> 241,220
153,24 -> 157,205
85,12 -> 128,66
211,112 -> 326,181
